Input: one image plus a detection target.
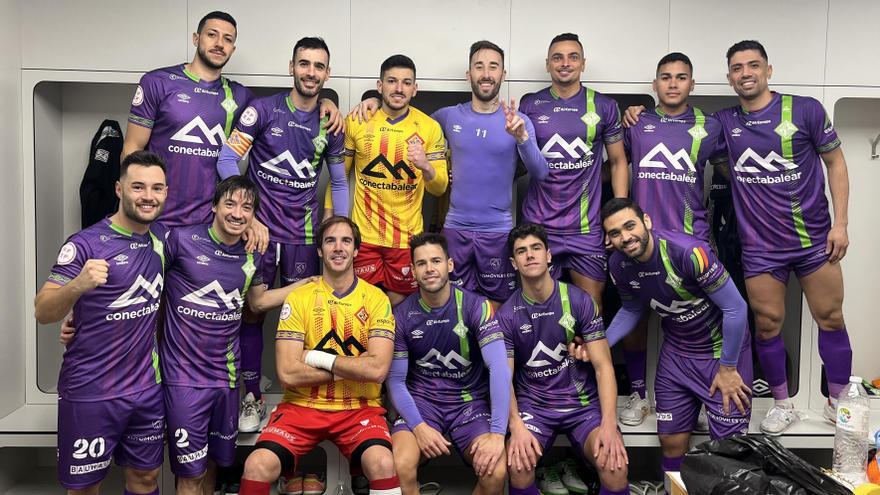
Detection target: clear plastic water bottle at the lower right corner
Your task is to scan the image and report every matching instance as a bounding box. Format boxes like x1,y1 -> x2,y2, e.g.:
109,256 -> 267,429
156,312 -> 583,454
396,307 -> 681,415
834,376 -> 870,486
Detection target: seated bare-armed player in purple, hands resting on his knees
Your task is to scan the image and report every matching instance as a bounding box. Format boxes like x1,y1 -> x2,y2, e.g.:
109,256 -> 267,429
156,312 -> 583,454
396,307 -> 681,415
485,224 -> 629,495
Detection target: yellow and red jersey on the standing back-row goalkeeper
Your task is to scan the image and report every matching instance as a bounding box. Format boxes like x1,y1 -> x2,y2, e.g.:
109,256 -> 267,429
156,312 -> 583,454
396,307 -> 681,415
334,107 -> 449,248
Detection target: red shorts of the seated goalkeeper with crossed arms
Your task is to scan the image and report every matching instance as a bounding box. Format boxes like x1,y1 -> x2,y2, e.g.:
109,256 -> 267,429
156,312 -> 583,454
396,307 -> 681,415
257,403 -> 391,467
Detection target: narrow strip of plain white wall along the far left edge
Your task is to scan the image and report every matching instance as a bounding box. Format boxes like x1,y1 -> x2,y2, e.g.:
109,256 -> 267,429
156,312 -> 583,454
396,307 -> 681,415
0,0 -> 22,417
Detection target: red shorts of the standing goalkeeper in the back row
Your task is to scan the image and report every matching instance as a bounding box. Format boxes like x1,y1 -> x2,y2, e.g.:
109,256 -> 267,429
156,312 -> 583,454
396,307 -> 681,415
354,243 -> 418,295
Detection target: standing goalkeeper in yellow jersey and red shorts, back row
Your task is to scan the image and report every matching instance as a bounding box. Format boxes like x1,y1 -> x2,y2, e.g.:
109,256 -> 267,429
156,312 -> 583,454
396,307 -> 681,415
325,55 -> 449,304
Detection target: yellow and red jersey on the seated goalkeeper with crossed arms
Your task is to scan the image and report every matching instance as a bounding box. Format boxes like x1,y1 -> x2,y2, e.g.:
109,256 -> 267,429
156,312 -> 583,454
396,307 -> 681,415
275,278 -> 394,411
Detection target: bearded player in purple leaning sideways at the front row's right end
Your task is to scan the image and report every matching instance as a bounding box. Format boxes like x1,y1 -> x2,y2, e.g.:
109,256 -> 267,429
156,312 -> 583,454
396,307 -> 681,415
602,198 -> 752,480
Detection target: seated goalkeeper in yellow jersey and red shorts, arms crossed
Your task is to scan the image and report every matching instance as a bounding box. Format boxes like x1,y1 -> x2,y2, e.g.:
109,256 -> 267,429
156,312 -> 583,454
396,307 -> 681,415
240,216 -> 400,495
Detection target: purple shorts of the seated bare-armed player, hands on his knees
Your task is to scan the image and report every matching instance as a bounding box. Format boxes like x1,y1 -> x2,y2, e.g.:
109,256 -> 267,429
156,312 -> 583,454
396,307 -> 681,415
517,397 -> 602,455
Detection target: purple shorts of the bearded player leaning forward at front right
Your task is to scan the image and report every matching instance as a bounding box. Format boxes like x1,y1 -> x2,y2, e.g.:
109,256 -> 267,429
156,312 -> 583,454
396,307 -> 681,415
654,338 -> 753,439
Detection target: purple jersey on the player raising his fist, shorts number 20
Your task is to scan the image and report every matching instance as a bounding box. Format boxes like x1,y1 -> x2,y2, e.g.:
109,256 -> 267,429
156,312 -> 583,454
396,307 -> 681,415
48,219 -> 164,402
